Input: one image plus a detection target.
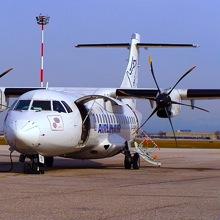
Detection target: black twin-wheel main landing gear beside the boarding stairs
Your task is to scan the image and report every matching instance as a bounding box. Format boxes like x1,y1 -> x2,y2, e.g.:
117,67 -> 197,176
124,141 -> 140,170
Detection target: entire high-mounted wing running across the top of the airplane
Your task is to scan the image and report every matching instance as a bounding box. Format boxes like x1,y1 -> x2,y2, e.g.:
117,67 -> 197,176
0,87 -> 220,104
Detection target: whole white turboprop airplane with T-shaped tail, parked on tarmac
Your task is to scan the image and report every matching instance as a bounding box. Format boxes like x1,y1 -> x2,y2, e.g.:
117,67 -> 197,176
0,34 -> 220,173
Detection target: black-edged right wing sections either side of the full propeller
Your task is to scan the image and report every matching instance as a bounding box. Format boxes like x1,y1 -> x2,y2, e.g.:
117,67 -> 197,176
116,88 -> 220,100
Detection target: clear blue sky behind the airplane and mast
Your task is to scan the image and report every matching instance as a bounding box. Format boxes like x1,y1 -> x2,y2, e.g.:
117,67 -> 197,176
0,0 -> 220,132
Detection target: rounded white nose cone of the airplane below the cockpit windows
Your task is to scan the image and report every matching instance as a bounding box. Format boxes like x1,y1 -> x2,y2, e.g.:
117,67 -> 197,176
5,120 -> 40,150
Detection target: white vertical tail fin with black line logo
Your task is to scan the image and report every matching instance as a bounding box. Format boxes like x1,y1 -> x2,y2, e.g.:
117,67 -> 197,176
120,33 -> 140,88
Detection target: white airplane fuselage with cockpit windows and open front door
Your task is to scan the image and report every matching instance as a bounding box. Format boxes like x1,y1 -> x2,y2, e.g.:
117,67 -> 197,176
4,90 -> 138,159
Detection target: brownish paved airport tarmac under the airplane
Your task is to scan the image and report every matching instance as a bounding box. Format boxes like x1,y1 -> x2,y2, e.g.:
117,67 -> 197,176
0,146 -> 220,220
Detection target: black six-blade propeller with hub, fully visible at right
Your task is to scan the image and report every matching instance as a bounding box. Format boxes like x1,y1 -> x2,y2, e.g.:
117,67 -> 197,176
137,57 -> 209,147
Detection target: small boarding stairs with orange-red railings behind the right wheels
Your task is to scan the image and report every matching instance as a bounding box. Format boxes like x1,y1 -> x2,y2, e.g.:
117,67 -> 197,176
134,131 -> 161,167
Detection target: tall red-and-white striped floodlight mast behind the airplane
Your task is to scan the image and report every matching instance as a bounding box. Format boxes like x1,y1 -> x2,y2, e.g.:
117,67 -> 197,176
36,14 -> 50,87
